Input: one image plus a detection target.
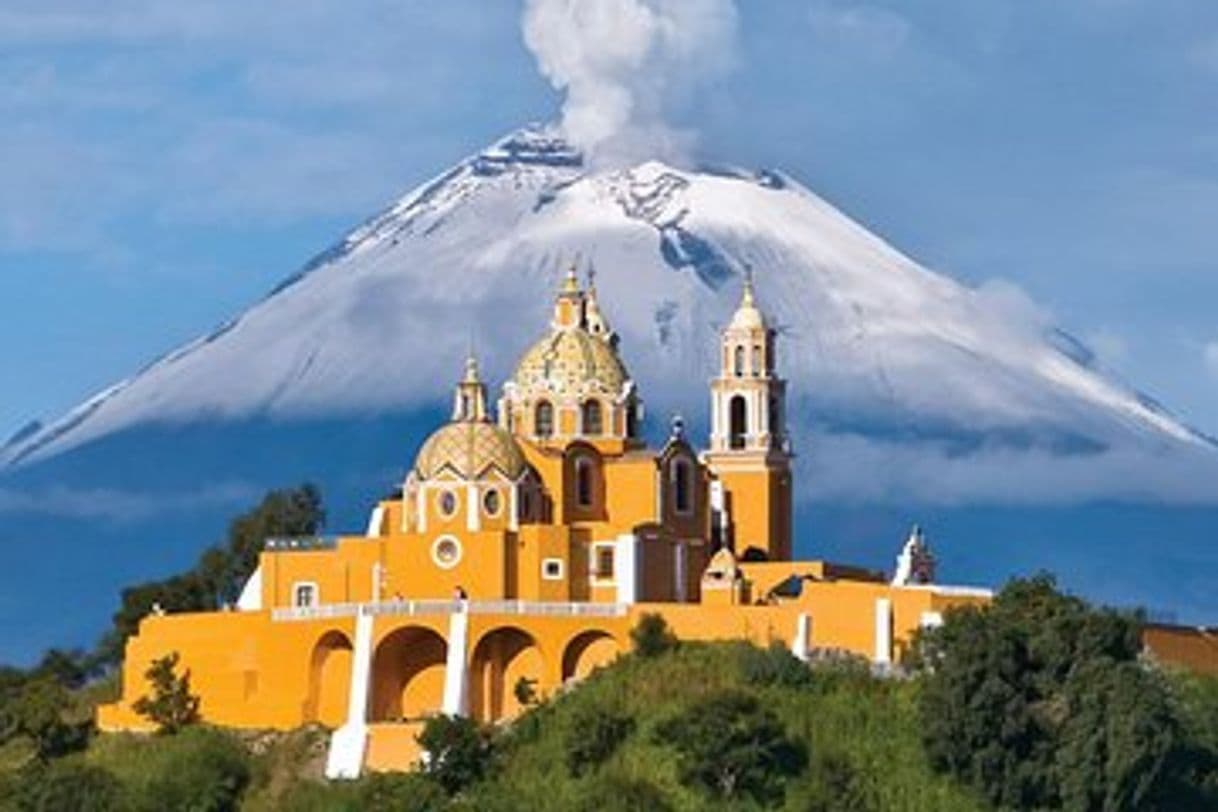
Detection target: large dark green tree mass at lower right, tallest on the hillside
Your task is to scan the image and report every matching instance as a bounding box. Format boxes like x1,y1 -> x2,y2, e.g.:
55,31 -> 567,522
921,576 -> 1177,810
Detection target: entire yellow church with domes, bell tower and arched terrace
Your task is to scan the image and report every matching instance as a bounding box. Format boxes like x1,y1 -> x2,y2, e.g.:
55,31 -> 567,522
99,269 -> 990,778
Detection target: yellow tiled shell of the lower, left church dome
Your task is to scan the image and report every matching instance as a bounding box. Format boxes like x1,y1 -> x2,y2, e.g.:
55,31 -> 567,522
414,420 -> 525,480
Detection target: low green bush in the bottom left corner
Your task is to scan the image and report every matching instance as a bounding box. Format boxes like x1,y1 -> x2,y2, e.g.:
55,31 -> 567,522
0,757 -> 127,812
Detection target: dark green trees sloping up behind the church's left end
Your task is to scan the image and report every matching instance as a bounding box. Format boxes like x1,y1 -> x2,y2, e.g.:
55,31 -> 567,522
97,483 -> 325,666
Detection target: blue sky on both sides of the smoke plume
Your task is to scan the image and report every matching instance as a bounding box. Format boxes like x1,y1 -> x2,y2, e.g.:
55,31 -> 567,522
0,0 -> 1218,445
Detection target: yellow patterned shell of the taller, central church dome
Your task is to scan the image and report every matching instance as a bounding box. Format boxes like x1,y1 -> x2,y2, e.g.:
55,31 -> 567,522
512,327 -> 630,396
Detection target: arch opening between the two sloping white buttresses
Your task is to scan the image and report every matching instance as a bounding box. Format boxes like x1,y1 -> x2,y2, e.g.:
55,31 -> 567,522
370,626 -> 448,722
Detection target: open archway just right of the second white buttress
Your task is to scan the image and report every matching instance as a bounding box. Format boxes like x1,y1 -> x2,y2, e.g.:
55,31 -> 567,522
469,627 -> 544,722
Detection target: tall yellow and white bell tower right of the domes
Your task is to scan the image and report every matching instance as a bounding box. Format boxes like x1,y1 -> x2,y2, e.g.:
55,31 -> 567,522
705,271 -> 792,561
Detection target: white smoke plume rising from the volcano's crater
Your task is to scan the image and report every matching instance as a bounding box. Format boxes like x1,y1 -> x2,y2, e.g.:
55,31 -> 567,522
524,0 -> 737,166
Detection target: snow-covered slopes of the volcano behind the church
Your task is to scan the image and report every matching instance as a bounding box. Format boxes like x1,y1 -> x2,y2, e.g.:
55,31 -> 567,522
0,128 -> 1218,500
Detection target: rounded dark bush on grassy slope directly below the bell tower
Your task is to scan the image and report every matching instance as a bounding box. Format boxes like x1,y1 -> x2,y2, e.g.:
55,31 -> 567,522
657,690 -> 808,803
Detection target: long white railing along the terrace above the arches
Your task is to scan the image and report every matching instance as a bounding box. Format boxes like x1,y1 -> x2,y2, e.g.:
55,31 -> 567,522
270,600 -> 627,621
